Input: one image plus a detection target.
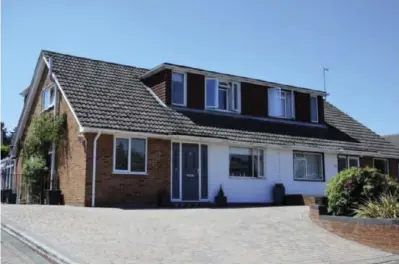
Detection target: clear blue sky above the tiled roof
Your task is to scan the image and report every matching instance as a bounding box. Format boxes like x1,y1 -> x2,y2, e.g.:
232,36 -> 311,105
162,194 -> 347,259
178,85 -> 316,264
1,0 -> 399,134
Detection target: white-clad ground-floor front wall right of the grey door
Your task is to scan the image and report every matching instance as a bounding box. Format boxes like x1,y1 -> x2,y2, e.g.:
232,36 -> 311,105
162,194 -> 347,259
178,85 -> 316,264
208,144 -> 337,202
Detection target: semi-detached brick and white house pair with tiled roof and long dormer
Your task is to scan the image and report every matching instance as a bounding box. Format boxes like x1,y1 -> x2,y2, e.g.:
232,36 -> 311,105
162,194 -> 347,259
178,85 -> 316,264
12,51 -> 399,206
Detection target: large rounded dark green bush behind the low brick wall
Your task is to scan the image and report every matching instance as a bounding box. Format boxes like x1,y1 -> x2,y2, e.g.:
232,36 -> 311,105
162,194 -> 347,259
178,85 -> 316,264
326,168 -> 399,215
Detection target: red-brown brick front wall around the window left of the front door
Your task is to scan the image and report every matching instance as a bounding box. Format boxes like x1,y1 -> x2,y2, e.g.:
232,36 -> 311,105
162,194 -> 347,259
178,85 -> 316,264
86,134 -> 170,206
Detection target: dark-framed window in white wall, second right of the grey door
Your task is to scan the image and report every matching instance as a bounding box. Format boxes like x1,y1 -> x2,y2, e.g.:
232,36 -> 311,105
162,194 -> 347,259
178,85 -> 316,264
294,151 -> 324,181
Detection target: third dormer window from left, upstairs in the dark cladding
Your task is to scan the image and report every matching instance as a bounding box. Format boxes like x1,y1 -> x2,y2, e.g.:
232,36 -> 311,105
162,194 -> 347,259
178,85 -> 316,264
268,88 -> 295,119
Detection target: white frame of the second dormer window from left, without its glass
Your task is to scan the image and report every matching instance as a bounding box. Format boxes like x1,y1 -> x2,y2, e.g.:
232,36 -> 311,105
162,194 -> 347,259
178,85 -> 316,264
204,77 -> 241,114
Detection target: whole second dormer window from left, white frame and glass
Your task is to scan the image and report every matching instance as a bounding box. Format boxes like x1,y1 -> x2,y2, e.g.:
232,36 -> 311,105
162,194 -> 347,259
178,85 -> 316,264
205,78 -> 241,112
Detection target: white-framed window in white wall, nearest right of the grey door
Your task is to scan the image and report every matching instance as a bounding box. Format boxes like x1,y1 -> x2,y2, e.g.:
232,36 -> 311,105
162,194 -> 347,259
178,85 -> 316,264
229,147 -> 265,178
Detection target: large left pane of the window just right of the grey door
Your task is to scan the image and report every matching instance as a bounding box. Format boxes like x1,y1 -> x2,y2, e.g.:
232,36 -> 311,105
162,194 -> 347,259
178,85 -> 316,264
230,147 -> 253,177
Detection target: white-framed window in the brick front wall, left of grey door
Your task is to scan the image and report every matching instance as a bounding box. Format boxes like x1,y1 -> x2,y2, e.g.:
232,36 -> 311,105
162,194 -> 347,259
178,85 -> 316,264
113,136 -> 147,175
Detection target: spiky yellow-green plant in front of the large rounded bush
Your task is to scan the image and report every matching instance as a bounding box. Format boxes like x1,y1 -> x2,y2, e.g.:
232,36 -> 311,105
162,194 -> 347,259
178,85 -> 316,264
355,194 -> 399,219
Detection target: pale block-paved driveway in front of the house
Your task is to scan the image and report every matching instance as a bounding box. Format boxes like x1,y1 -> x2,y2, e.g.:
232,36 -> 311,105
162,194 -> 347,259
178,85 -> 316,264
1,205 -> 397,263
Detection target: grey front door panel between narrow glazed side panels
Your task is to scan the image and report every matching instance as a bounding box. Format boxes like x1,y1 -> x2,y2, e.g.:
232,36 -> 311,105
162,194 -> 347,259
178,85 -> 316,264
182,144 -> 199,201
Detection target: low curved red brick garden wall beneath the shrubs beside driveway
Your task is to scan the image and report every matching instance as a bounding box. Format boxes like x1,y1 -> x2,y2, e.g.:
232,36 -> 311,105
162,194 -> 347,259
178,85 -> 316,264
309,206 -> 399,253
